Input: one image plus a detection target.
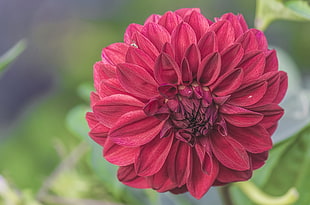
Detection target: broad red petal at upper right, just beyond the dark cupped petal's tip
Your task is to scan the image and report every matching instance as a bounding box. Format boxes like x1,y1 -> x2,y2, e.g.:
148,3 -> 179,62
238,51 -> 265,81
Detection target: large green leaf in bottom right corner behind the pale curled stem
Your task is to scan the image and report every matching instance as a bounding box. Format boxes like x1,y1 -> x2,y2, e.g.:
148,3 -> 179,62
230,122 -> 310,205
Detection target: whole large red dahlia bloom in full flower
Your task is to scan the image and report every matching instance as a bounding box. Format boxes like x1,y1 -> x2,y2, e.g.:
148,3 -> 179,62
87,9 -> 287,198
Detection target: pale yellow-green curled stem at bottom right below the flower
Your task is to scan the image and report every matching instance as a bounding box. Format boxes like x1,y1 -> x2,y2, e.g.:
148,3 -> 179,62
234,181 -> 299,205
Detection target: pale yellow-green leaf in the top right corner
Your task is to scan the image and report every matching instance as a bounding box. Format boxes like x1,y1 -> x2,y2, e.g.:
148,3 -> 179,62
255,0 -> 310,30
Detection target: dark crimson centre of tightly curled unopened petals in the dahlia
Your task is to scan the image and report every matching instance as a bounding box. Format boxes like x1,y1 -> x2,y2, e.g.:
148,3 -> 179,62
144,83 -> 227,146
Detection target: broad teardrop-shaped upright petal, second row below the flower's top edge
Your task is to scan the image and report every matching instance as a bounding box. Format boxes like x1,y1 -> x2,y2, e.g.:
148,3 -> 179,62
171,22 -> 197,64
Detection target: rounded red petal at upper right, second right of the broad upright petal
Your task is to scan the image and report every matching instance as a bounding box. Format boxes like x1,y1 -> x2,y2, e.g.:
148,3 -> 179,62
209,21 -> 235,51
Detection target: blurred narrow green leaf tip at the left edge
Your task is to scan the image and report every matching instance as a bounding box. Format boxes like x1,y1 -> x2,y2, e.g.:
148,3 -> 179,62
0,39 -> 26,72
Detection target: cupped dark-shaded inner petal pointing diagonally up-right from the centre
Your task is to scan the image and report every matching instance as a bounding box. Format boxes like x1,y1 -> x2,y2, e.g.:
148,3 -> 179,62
210,69 -> 244,96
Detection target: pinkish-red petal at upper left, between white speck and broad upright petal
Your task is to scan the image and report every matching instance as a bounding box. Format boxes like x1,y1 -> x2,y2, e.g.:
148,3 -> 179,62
141,23 -> 171,52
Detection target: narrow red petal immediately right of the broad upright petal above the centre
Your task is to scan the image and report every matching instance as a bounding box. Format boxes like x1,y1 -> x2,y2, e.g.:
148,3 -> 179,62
198,31 -> 218,59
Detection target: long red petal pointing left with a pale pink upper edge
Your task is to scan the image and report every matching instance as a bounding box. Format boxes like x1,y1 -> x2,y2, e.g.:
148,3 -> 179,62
93,94 -> 144,127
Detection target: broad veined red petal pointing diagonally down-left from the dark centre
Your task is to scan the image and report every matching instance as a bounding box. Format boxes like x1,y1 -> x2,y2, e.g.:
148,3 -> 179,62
135,135 -> 173,176
